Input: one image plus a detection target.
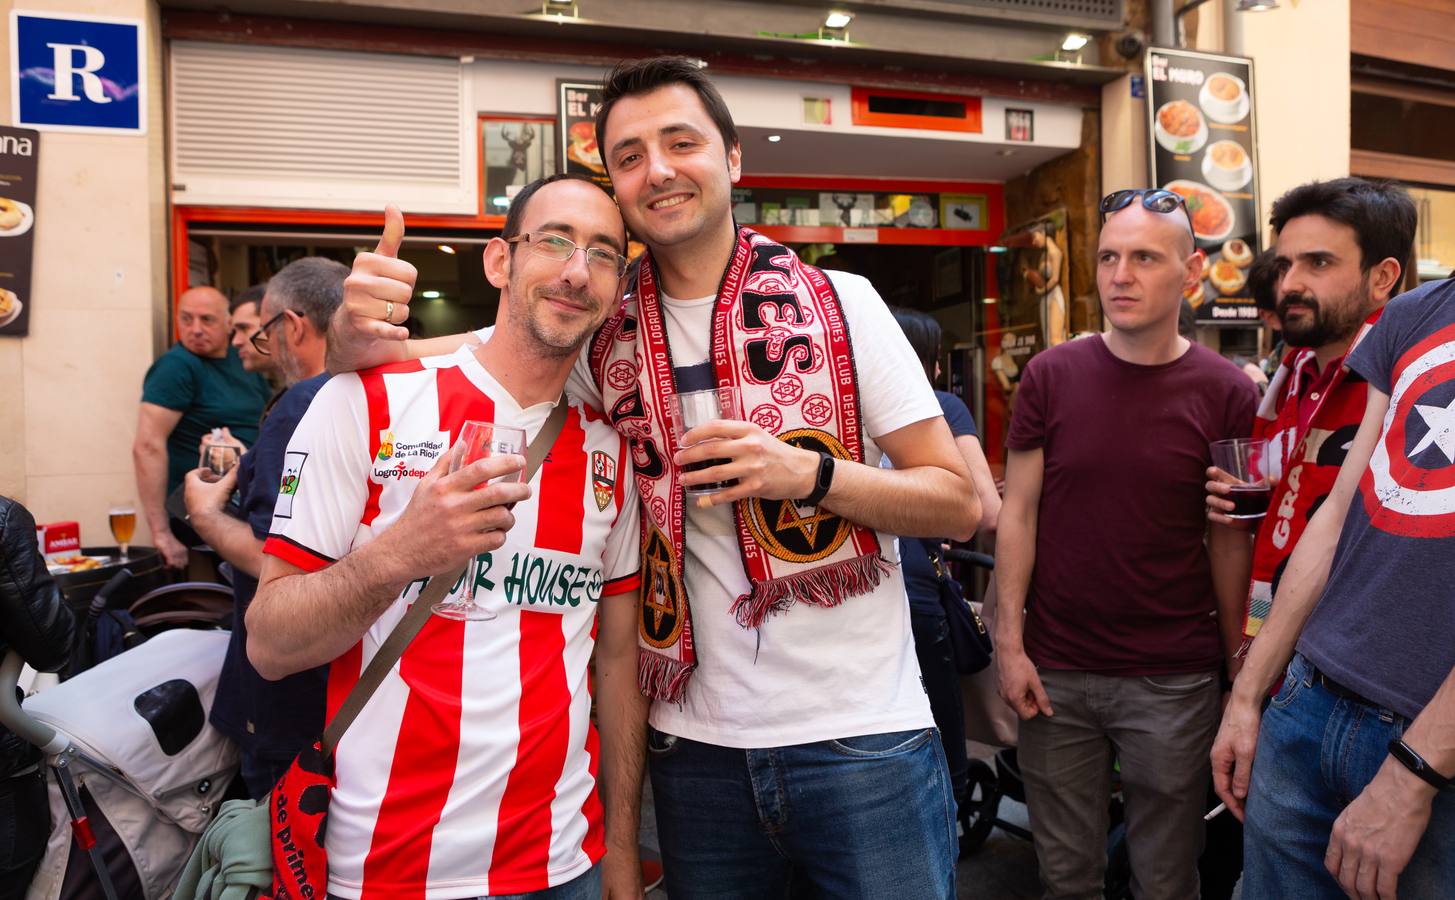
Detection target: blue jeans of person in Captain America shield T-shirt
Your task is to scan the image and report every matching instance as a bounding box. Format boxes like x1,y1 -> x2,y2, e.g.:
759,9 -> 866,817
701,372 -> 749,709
1243,654 -> 1455,900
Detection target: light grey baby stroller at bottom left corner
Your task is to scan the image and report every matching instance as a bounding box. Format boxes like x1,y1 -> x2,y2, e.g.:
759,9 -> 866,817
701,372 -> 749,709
0,628 -> 237,900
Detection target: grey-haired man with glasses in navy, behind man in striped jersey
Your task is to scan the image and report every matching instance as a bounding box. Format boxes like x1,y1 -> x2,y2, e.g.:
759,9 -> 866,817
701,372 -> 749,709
186,256 -> 349,800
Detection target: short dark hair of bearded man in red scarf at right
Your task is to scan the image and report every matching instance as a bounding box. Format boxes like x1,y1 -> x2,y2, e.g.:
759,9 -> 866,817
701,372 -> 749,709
1269,177 -> 1419,272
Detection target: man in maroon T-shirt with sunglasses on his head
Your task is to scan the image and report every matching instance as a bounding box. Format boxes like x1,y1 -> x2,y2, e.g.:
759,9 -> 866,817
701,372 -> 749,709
995,190 -> 1257,900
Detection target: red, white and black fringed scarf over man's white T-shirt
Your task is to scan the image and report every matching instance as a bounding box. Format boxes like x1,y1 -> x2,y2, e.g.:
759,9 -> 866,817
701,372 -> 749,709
591,228 -> 892,702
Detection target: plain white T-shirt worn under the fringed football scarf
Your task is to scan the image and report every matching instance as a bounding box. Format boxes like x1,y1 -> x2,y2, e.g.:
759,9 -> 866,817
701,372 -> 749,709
555,272 -> 941,747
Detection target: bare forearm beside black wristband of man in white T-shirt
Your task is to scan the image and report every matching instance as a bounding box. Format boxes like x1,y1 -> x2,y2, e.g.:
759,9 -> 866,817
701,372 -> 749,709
824,459 -> 981,541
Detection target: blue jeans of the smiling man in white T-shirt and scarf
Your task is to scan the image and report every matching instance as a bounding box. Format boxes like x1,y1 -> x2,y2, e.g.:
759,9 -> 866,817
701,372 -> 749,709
647,728 -> 954,900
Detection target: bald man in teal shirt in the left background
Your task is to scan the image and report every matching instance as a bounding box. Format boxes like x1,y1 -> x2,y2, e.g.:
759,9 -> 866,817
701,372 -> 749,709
132,286 -> 272,568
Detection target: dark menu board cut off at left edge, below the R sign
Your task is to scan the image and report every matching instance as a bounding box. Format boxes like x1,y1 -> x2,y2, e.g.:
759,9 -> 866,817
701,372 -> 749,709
0,128 -> 41,337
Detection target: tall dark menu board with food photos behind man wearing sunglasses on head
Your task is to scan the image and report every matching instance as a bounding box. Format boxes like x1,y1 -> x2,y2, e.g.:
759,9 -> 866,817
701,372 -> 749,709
1147,48 -> 1259,326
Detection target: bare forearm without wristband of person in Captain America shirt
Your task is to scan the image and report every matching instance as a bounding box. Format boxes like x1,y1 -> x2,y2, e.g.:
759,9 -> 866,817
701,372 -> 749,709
1232,497 -> 1343,704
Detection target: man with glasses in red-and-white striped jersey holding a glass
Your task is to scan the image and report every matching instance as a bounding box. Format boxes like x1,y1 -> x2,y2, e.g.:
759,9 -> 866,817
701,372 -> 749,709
246,176 -> 646,900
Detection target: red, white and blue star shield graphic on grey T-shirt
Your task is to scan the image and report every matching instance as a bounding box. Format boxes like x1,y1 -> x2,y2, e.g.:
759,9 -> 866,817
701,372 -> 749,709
1359,324 -> 1455,538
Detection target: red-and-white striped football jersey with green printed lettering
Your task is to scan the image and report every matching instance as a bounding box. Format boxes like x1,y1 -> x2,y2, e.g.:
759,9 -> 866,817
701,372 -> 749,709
263,349 -> 639,900
